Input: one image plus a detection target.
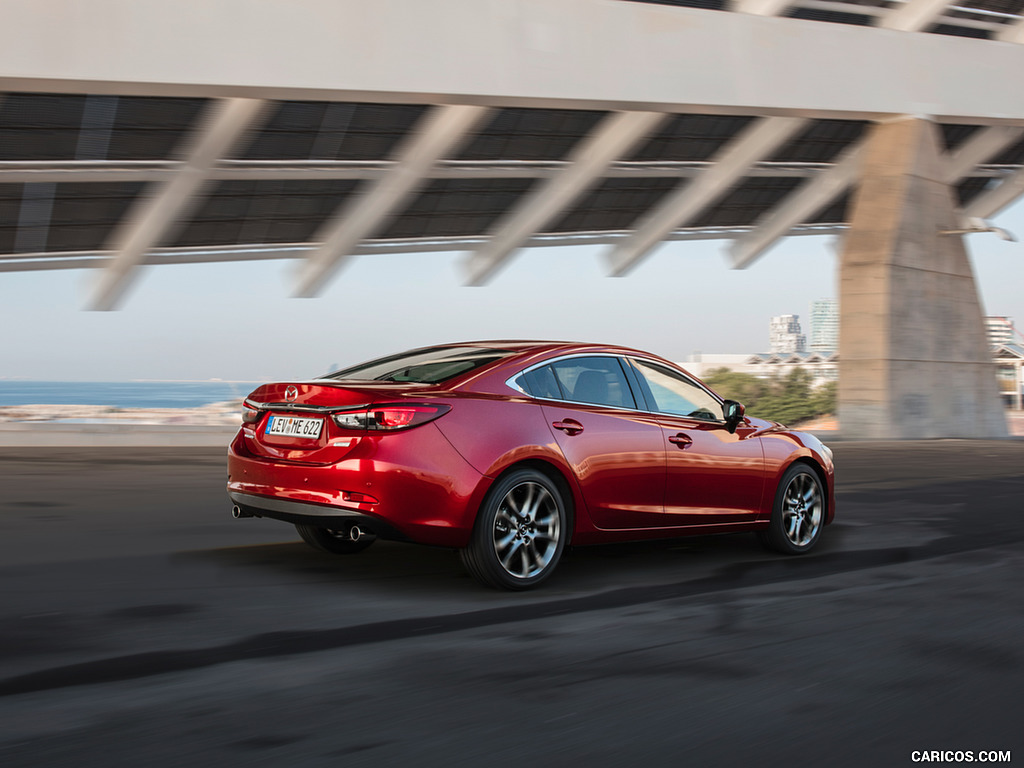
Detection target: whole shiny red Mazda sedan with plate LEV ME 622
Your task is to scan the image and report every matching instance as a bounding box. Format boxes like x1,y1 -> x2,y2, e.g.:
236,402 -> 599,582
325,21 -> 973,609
227,341 -> 836,590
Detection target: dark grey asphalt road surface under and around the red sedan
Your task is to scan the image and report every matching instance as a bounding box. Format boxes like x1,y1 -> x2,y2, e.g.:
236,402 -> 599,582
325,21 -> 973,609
0,440 -> 1024,768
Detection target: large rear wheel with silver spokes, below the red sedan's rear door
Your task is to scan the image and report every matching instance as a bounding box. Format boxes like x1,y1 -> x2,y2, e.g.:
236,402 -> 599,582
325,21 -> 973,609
460,468 -> 569,591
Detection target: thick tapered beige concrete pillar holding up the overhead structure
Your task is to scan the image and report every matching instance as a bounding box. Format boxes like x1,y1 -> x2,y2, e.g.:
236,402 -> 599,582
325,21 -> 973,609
839,118 -> 1007,439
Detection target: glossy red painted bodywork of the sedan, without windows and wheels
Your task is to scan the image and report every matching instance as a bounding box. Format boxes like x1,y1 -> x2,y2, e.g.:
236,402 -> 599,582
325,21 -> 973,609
227,342 -> 836,547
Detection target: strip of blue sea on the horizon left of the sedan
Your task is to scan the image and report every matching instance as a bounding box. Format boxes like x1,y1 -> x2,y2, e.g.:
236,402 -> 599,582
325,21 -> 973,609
0,380 -> 260,408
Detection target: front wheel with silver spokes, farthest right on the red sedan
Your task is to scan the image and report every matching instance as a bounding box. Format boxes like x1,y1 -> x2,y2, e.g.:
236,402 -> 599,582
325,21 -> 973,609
758,463 -> 825,555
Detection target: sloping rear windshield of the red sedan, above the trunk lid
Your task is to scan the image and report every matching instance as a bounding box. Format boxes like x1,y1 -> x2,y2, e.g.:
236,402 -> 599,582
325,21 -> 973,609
323,347 -> 512,384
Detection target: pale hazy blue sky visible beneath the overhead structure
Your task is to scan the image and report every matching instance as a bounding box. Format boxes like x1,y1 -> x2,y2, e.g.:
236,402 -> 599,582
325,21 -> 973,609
0,195 -> 1024,381
